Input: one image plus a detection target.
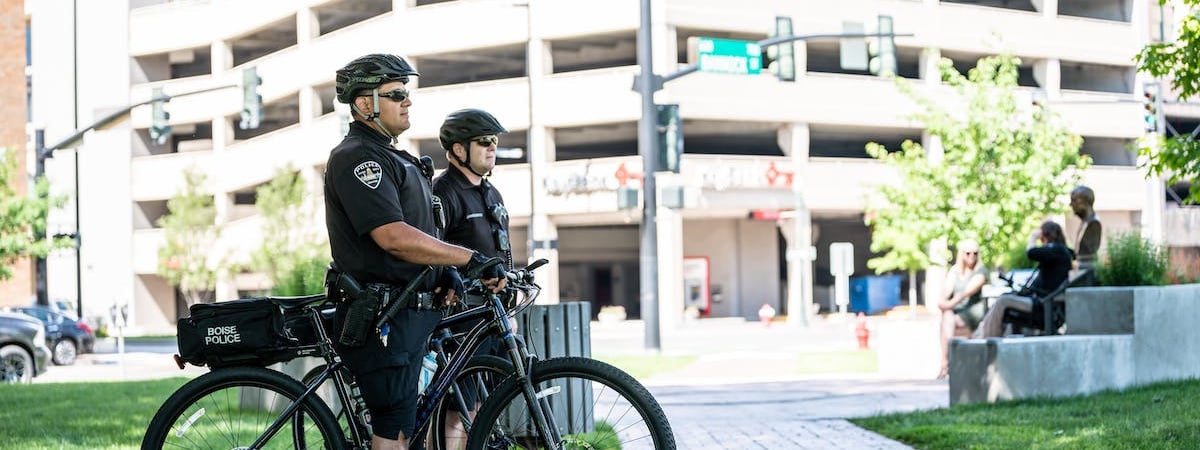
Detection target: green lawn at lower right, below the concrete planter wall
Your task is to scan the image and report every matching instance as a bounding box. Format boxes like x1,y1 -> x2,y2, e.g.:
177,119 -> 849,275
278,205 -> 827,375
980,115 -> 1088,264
852,379 -> 1200,450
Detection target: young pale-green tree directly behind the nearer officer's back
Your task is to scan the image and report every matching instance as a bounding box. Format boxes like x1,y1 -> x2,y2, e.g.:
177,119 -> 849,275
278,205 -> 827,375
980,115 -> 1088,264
251,166 -> 330,295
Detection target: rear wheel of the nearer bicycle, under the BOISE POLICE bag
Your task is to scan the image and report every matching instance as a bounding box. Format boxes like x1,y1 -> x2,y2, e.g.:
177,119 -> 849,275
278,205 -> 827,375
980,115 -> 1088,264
142,367 -> 346,450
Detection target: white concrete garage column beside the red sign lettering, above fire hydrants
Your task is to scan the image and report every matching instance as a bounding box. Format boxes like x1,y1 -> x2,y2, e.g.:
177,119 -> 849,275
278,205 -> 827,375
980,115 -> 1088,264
778,124 -> 816,326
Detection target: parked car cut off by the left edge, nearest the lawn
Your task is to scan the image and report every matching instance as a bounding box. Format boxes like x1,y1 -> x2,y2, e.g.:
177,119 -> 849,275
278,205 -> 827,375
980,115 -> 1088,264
0,311 -> 50,383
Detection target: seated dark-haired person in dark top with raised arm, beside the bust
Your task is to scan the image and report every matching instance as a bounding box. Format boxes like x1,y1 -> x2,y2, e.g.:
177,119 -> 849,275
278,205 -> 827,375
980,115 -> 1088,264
971,221 -> 1075,337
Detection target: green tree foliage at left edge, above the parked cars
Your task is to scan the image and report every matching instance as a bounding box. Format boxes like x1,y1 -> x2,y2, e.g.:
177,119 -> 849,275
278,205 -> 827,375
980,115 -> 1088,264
0,149 -> 72,280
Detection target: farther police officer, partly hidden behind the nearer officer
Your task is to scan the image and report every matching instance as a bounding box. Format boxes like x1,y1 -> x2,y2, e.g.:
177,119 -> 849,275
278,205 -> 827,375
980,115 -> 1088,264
433,109 -> 515,449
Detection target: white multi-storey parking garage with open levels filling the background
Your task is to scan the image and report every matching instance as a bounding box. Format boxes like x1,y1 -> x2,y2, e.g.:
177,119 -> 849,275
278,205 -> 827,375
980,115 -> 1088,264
25,0 -> 1200,332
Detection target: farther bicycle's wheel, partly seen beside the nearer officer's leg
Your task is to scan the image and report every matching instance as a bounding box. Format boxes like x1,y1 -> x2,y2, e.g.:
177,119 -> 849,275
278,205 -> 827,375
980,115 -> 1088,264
430,355 -> 516,450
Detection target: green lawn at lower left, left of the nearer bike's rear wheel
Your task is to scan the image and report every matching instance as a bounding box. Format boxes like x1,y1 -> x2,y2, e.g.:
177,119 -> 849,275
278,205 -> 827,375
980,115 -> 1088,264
0,378 -> 187,449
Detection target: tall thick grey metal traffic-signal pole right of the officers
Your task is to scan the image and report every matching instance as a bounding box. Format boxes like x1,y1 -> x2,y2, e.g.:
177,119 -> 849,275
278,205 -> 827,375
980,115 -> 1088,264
637,0 -> 661,350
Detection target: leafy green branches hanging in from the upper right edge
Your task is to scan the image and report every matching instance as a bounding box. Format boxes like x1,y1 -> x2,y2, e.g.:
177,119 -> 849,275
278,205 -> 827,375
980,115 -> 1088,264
1134,0 -> 1200,203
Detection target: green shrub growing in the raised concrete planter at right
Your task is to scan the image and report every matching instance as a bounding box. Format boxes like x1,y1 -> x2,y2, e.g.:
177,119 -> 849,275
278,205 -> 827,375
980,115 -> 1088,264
1096,233 -> 1168,286
